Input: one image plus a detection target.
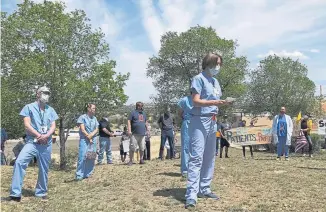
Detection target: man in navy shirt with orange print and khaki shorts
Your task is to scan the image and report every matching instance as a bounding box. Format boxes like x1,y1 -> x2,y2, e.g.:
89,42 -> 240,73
128,102 -> 148,166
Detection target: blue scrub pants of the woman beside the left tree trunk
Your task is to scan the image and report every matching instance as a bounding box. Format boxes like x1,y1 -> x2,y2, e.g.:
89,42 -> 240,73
76,139 -> 96,180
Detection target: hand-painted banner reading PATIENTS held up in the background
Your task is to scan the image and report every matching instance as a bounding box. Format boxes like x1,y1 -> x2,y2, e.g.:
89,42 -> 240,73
226,126 -> 272,146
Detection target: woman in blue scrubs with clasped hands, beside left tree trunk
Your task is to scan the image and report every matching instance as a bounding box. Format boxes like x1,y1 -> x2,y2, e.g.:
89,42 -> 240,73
76,104 -> 99,180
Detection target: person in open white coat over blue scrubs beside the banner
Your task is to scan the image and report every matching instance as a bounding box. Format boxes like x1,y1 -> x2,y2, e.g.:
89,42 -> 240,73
272,107 -> 293,160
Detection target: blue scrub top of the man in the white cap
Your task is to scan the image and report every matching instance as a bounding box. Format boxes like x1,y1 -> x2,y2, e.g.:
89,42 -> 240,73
19,102 -> 59,143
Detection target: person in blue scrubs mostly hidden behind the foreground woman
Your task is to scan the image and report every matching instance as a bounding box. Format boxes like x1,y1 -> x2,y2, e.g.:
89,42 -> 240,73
178,96 -> 193,177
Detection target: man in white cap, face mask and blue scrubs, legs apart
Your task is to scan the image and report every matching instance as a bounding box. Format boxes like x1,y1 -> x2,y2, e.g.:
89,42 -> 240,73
10,87 -> 58,202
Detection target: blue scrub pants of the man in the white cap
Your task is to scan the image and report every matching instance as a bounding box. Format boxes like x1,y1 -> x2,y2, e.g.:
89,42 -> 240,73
10,143 -> 52,197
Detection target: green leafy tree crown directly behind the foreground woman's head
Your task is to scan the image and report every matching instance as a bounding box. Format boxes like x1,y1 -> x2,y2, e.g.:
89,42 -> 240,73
147,26 -> 248,116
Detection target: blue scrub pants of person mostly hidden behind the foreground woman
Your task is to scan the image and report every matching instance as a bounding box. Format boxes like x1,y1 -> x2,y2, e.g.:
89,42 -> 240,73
181,120 -> 190,174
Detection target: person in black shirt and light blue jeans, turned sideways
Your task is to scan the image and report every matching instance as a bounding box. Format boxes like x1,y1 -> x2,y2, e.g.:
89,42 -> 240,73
97,113 -> 114,165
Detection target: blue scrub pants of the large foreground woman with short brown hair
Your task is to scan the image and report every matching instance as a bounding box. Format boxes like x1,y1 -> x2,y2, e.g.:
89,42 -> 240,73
186,116 -> 217,201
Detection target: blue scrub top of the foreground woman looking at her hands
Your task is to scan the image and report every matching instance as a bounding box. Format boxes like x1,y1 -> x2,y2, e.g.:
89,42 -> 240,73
190,72 -> 222,116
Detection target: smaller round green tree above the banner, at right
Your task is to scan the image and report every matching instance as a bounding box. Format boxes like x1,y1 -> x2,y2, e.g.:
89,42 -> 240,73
243,55 -> 315,116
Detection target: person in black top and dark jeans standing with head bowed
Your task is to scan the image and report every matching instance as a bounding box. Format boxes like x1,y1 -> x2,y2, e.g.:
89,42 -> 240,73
158,107 -> 175,160
